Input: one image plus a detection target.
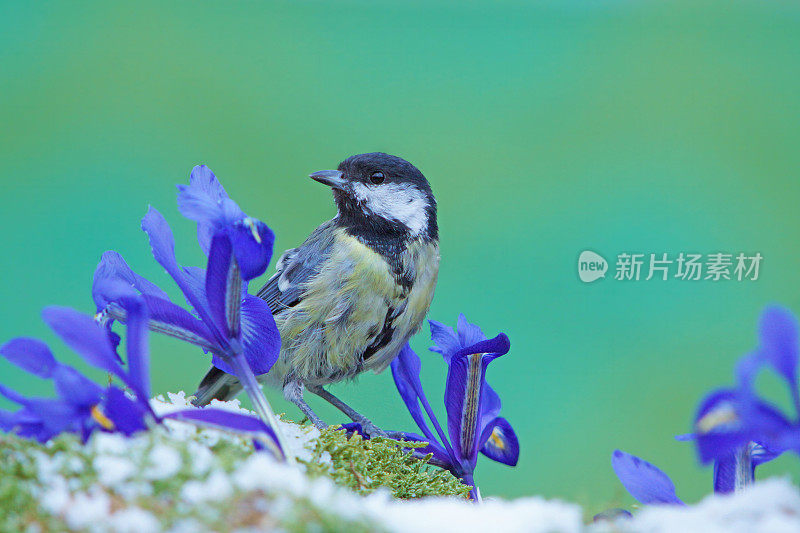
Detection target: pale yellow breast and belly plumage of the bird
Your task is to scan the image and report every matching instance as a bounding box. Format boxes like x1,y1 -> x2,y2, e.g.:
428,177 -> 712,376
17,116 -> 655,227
276,230 -> 439,383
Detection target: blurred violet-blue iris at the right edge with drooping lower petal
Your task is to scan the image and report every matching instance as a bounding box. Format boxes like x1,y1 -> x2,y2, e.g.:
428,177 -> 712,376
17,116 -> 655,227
611,306 -> 800,505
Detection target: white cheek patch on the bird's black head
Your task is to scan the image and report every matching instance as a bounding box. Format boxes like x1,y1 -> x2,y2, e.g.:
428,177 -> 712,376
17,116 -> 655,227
353,182 -> 428,235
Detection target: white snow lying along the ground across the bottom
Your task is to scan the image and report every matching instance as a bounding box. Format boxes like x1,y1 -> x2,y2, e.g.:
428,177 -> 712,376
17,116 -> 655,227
10,393 -> 800,533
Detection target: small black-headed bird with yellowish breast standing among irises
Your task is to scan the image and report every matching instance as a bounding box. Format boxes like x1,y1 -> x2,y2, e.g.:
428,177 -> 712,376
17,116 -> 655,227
194,152 -> 439,432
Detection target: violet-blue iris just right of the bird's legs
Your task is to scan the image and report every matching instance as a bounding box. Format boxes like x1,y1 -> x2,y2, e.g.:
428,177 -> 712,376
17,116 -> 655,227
392,315 -> 519,501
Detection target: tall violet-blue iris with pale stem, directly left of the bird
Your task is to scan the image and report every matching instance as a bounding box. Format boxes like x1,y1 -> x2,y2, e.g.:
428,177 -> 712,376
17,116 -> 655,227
92,166 -> 288,460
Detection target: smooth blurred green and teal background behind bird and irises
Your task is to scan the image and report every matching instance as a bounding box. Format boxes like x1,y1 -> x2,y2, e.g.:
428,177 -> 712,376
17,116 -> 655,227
0,0 -> 800,511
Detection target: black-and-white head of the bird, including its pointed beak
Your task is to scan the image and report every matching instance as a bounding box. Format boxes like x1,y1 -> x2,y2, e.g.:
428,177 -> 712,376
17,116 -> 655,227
310,152 -> 438,239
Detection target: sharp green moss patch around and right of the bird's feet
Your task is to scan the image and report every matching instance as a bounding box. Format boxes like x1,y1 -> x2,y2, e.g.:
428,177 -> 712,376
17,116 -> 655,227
303,428 -> 470,499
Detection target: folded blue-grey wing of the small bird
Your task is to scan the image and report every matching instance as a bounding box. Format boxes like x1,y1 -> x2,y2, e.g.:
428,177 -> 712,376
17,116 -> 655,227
258,220 -> 334,314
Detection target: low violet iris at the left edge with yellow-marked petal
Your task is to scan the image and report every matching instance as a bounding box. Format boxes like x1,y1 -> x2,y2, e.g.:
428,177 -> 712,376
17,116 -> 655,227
0,296 -> 275,448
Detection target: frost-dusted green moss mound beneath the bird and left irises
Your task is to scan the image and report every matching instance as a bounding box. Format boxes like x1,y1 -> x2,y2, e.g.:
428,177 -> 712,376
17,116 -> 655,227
0,394 -> 468,533
